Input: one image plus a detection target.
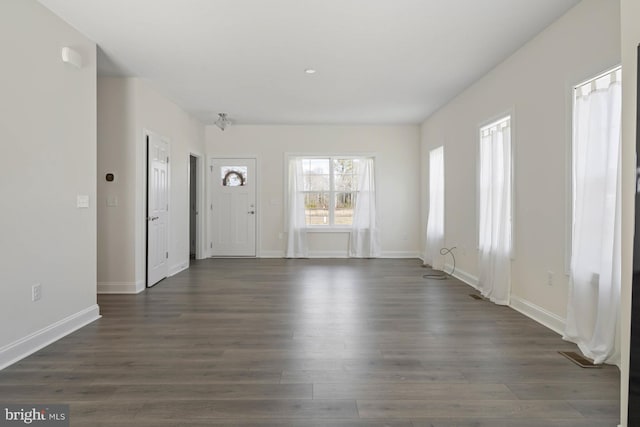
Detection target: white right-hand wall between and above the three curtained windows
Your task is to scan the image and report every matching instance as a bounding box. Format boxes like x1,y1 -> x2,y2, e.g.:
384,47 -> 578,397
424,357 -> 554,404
421,0 -> 620,330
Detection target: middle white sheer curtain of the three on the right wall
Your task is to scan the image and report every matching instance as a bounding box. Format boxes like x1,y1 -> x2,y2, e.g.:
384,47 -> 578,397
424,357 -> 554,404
479,117 -> 512,305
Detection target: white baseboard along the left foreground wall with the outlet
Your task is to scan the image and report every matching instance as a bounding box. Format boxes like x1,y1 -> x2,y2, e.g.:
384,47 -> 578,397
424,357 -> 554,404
0,304 -> 101,370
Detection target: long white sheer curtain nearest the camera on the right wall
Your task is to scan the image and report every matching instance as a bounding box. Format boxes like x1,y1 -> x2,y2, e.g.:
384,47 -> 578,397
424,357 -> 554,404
564,70 -> 622,364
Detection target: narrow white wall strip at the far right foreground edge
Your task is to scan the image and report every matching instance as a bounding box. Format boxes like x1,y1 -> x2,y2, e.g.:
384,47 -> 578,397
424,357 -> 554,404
620,0 -> 640,426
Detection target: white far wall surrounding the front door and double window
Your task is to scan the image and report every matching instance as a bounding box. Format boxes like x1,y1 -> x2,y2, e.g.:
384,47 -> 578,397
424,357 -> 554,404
206,126 -> 420,257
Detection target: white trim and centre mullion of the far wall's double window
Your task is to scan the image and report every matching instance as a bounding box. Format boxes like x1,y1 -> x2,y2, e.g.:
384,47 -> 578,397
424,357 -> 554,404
283,152 -> 378,233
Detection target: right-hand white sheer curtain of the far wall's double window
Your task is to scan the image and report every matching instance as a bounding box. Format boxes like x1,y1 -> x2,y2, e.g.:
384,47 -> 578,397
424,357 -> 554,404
349,158 -> 380,258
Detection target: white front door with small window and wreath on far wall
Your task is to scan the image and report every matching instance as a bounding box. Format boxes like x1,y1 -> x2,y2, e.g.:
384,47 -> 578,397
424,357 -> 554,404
209,159 -> 257,256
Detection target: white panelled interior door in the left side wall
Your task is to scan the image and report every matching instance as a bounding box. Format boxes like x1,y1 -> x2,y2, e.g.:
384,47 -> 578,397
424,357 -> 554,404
147,134 -> 169,286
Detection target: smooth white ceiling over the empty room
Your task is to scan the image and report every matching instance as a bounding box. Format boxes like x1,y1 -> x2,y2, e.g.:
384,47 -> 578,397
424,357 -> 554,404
39,0 -> 579,124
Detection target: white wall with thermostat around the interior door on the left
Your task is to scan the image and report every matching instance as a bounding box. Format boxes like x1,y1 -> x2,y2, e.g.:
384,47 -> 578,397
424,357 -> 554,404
98,78 -> 205,293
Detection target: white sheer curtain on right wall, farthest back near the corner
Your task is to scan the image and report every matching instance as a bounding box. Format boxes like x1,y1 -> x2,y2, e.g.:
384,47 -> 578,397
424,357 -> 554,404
424,146 -> 444,270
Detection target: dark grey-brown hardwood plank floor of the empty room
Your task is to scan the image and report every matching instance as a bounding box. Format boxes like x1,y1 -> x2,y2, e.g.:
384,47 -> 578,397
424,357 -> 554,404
0,259 -> 619,427
